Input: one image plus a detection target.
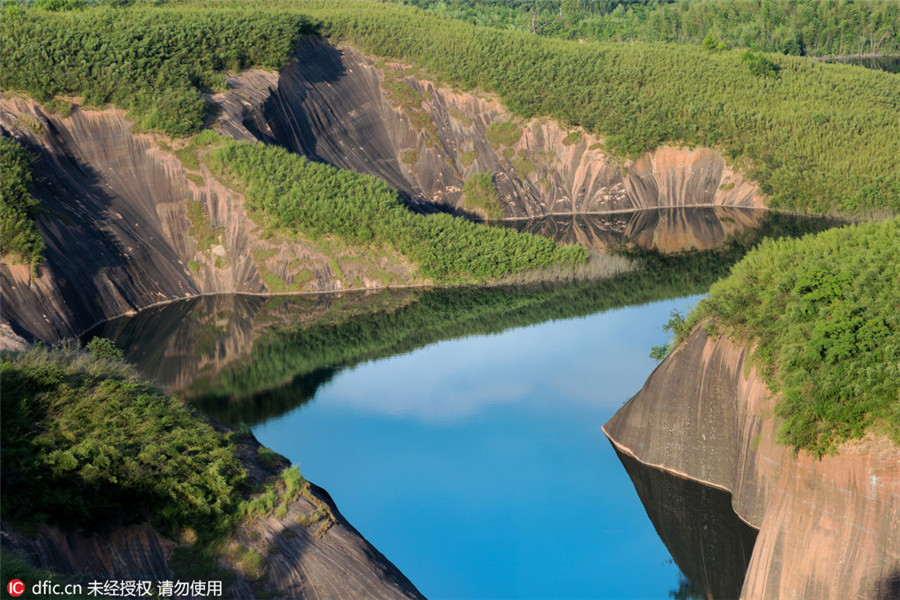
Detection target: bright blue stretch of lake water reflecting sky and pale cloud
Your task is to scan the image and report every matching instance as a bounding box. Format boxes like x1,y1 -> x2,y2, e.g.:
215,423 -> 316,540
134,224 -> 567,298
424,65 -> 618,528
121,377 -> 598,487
254,297 -> 698,599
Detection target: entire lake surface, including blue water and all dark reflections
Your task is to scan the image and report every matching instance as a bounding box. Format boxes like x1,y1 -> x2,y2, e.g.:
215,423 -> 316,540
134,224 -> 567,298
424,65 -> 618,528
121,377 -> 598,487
92,211 -> 828,598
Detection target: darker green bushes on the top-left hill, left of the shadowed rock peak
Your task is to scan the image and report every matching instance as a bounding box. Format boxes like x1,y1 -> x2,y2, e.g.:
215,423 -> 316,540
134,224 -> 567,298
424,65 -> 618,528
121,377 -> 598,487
0,2 -> 310,135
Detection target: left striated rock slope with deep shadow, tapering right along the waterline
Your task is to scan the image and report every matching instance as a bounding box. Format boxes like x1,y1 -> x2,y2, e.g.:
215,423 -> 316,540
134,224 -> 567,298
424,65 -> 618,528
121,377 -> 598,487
0,99 -> 411,341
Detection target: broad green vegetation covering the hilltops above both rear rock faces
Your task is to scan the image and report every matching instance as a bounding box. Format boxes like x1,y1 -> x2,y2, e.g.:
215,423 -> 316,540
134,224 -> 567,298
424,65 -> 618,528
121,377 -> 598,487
0,0 -> 900,214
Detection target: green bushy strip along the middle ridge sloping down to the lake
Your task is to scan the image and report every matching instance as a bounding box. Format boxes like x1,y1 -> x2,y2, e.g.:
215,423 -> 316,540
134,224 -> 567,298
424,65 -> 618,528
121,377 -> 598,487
206,142 -> 587,283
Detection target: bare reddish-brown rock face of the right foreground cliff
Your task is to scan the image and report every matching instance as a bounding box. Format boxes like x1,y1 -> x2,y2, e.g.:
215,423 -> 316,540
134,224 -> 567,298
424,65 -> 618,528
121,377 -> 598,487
604,328 -> 900,600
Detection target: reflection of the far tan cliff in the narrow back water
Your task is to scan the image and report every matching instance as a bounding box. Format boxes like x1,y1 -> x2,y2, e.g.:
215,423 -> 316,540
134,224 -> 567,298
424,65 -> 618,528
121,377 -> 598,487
502,206 -> 767,252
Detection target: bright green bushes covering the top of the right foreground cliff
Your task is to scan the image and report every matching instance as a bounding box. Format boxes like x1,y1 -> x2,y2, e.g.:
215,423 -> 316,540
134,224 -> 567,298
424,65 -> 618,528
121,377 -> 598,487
681,219 -> 900,455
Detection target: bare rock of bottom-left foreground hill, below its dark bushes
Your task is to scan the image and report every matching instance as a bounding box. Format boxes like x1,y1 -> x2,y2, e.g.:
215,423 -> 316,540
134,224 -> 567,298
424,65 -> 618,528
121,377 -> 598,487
0,428 -> 422,600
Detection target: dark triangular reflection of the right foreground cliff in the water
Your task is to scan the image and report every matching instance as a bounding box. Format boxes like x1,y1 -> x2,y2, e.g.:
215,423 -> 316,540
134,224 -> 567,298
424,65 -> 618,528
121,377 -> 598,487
613,446 -> 758,600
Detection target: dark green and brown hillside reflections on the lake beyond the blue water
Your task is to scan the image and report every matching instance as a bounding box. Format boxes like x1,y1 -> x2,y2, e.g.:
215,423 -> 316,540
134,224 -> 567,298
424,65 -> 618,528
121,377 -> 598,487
86,208 -> 833,425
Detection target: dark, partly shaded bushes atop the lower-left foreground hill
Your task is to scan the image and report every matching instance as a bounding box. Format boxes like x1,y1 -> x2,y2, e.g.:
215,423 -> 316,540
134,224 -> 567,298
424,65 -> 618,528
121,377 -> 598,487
0,345 -> 246,535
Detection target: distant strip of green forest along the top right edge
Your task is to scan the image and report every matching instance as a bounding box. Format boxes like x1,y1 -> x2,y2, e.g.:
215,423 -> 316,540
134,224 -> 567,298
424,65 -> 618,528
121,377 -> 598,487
396,0 -> 900,56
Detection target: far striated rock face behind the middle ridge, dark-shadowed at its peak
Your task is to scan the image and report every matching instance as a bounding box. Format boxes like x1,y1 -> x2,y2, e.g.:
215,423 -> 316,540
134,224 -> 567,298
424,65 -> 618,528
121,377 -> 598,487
234,37 -> 763,217
